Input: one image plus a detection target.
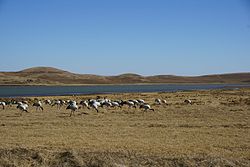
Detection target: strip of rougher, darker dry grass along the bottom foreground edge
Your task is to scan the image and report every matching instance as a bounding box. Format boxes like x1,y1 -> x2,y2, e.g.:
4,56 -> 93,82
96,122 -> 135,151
0,148 -> 250,167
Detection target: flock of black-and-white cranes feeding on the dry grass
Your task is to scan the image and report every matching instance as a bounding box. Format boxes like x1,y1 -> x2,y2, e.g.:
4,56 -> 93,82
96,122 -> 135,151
0,96 -> 192,116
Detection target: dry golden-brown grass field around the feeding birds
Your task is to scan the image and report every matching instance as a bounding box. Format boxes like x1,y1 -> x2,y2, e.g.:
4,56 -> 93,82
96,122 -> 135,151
0,89 -> 250,167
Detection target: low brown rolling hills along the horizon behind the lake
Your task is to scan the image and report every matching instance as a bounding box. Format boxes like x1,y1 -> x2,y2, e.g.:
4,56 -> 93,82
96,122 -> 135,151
0,67 -> 250,85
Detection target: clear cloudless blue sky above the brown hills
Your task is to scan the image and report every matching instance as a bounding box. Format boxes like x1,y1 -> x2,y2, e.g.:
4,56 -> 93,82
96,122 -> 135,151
0,0 -> 250,75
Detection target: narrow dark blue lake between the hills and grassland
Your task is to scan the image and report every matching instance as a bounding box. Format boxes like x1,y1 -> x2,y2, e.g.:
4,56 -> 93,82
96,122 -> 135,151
0,84 -> 250,97
